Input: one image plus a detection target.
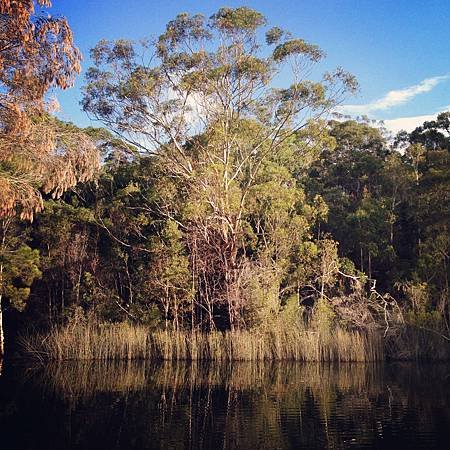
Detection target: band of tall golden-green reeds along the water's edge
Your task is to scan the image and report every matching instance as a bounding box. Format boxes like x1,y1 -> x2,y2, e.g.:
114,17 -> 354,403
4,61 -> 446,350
22,322 -> 384,362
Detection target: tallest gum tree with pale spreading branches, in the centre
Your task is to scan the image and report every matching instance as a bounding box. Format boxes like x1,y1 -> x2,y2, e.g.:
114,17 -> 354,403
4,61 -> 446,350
82,7 -> 357,329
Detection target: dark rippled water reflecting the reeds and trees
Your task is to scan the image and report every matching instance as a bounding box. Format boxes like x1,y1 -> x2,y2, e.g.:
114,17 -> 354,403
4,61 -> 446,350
0,363 -> 450,450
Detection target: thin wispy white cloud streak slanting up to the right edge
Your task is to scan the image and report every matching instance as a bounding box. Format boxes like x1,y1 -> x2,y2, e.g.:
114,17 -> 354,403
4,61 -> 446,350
339,75 -> 450,115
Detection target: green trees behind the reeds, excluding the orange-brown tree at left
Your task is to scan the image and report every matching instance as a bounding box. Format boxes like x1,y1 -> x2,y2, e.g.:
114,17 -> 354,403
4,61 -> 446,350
0,7 -> 450,356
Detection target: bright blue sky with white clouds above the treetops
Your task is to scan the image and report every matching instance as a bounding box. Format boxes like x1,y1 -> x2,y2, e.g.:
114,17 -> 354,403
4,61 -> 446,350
47,0 -> 450,131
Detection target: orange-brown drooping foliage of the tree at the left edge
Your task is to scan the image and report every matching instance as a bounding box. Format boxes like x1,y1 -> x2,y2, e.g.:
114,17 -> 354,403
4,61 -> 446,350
0,0 -> 98,355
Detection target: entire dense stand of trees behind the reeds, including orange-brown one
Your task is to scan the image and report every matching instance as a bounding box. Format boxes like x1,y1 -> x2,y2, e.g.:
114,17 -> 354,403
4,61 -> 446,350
0,0 -> 450,359
